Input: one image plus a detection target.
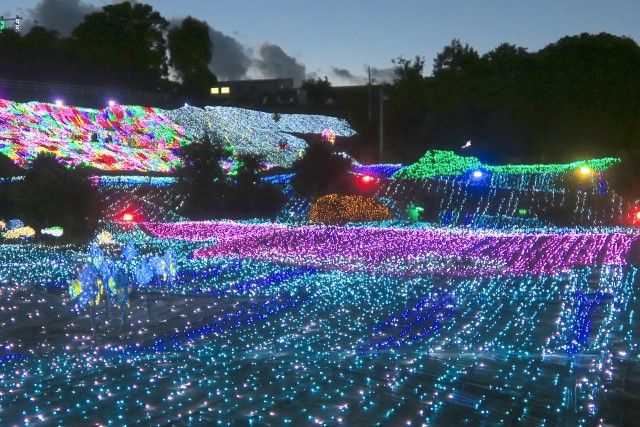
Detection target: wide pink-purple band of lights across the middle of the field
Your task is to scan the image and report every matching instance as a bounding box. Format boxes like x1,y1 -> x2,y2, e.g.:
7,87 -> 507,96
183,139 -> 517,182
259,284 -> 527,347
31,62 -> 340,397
145,221 -> 638,275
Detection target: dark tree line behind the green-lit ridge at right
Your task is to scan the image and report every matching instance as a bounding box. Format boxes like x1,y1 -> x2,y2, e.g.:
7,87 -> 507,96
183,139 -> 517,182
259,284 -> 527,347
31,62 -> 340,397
345,33 -> 640,169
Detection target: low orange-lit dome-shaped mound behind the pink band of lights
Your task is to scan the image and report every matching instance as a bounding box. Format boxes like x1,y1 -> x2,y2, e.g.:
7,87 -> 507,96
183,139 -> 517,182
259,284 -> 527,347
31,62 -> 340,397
309,196 -> 393,224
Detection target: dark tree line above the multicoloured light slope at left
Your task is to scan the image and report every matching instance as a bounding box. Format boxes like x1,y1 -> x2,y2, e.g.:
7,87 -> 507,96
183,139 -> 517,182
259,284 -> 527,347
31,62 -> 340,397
0,2 -> 216,101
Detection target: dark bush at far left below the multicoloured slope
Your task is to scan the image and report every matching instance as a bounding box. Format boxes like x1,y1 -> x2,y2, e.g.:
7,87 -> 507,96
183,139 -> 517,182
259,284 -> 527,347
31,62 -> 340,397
10,155 -> 101,239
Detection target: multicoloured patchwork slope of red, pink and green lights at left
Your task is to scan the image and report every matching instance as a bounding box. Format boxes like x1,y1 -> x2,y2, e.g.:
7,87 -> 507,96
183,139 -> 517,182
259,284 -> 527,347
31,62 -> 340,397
0,100 -> 190,172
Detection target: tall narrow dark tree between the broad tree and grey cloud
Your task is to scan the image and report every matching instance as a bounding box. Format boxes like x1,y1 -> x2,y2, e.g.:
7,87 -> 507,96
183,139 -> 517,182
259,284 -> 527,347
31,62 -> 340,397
168,16 -> 216,97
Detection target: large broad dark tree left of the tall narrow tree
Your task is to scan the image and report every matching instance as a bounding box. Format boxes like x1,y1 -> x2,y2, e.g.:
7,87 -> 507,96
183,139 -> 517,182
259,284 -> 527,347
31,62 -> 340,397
72,2 -> 169,89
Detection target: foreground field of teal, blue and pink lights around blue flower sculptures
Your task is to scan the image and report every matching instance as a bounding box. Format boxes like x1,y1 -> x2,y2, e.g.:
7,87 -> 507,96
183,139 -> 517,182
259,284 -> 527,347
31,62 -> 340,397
0,222 -> 640,425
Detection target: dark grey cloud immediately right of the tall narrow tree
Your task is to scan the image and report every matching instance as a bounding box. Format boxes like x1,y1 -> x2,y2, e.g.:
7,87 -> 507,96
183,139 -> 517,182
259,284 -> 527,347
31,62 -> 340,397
209,26 -> 253,80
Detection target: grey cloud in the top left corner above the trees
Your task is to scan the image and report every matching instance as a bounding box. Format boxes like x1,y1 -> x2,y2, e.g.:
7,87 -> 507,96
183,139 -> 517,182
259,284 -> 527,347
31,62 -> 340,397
23,0 -> 100,36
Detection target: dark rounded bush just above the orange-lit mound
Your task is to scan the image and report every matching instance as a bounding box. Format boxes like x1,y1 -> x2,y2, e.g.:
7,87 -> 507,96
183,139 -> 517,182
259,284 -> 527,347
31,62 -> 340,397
292,143 -> 352,196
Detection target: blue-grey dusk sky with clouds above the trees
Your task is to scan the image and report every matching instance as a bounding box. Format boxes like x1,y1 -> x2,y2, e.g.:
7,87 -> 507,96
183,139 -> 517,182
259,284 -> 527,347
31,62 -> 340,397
0,0 -> 640,85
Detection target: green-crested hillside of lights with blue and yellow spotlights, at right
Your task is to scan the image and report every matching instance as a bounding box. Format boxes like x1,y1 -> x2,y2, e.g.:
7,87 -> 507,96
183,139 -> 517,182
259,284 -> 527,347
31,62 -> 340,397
375,150 -> 632,228
